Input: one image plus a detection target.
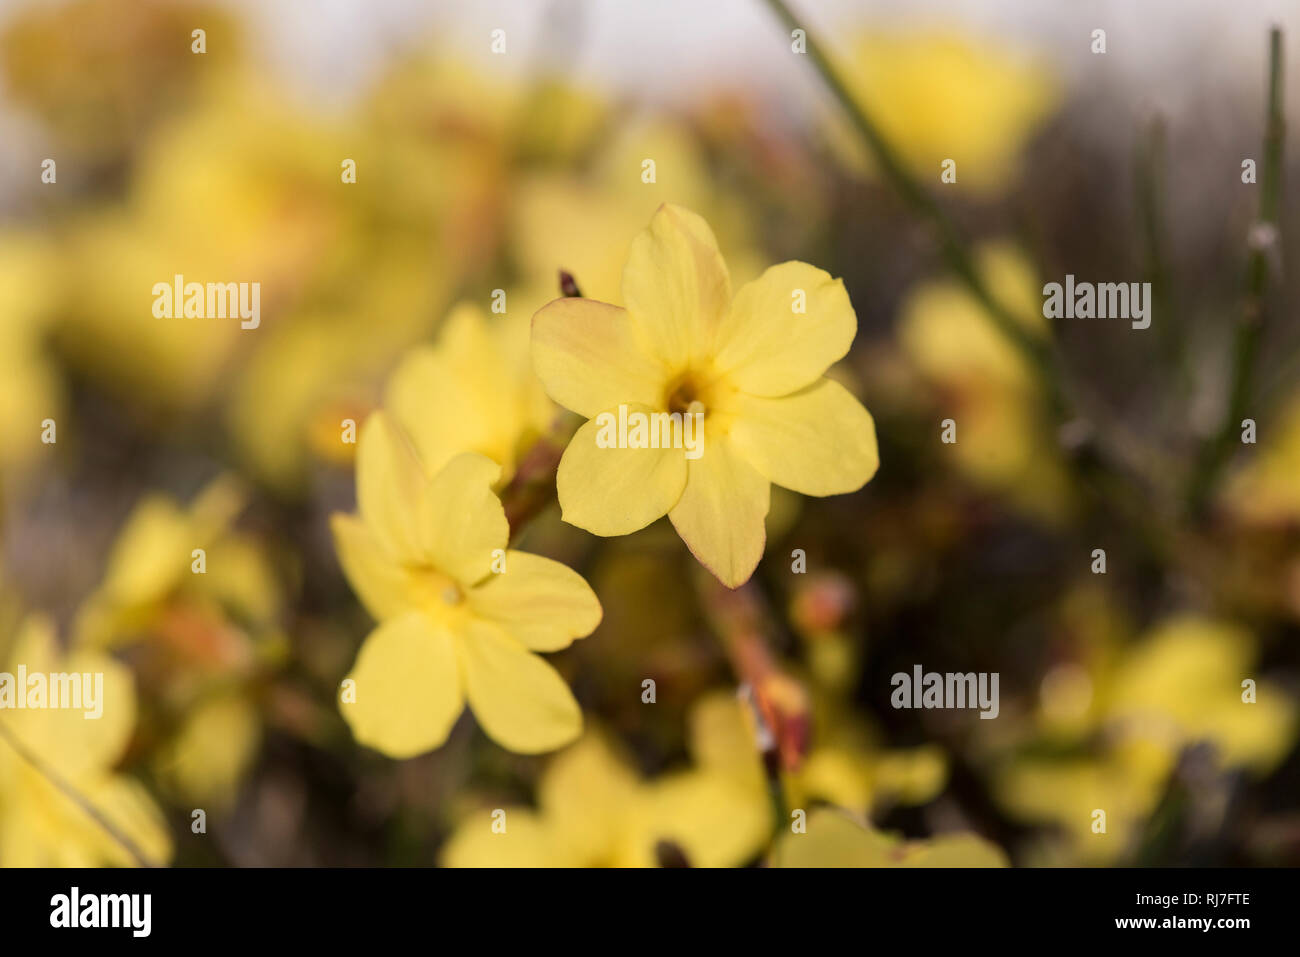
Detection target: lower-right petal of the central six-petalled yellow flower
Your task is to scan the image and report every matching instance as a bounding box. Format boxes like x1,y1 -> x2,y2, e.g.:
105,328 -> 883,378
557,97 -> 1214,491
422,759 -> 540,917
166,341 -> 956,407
733,378 -> 880,495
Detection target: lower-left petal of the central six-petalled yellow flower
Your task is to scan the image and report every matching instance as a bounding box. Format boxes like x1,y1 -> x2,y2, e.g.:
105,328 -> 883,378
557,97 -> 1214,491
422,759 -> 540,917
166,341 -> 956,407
555,403 -> 686,536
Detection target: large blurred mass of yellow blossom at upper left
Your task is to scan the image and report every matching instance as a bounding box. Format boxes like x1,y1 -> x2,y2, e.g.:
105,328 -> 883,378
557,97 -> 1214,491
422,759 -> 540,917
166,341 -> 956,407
61,73 -> 469,434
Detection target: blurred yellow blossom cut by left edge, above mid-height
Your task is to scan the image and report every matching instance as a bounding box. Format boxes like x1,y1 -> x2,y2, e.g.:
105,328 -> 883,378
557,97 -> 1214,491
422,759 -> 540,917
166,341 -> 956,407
0,233 -> 66,473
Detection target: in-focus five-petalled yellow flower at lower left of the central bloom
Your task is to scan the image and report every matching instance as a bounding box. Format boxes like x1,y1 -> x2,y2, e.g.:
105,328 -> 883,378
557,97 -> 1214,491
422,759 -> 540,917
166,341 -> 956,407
332,412 -> 601,758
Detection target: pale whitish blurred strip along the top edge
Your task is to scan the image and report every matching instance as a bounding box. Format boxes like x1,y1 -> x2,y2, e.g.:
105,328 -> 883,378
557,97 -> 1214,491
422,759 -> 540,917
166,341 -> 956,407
0,0 -> 1300,123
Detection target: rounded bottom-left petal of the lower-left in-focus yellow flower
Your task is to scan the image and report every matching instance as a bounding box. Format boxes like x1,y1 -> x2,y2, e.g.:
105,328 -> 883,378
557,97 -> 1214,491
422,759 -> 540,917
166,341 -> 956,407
339,612 -> 464,758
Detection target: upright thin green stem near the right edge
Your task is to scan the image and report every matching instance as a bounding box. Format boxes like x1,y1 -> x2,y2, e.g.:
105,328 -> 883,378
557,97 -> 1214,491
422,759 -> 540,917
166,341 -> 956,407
1188,27 -> 1286,511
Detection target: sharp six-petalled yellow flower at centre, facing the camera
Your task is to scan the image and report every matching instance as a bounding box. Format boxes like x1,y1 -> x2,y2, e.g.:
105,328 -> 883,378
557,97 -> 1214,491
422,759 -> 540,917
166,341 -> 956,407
533,204 -> 879,588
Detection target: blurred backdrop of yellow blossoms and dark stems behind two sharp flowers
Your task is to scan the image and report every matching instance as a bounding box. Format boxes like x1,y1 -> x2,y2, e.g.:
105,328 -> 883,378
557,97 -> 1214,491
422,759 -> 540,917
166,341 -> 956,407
0,0 -> 1300,866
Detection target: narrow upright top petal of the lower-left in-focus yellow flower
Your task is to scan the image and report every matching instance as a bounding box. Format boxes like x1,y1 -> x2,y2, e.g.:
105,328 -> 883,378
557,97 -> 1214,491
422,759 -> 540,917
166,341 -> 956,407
356,412 -> 425,559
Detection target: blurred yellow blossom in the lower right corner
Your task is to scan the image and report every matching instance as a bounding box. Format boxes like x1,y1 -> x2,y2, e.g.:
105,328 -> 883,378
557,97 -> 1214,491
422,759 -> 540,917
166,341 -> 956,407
996,616 -> 1297,862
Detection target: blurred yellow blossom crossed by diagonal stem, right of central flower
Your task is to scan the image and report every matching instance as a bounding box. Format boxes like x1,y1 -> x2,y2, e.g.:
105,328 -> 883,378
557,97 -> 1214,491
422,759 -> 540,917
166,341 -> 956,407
898,244 -> 1070,521
